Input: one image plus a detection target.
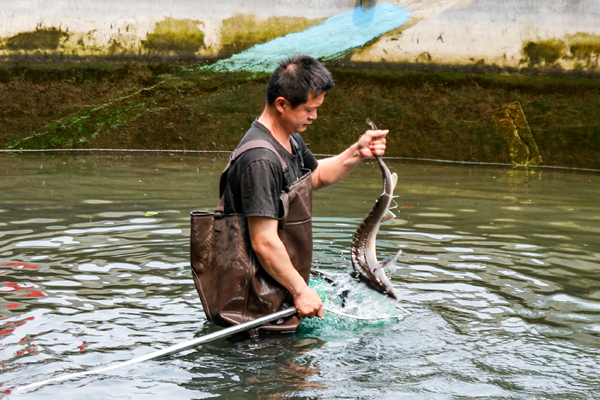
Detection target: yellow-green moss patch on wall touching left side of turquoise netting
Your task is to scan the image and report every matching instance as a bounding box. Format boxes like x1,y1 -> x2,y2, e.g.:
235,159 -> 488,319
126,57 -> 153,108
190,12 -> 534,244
221,14 -> 320,54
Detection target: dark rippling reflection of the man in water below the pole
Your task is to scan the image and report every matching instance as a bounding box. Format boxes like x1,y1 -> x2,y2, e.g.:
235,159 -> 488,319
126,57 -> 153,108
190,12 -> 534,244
175,332 -> 323,399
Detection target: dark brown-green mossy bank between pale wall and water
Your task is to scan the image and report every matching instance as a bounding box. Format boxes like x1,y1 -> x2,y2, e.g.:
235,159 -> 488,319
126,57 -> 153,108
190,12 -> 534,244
0,60 -> 600,169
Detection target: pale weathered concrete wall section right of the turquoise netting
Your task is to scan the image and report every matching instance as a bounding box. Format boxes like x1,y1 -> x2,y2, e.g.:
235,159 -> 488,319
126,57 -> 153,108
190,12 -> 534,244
352,0 -> 600,68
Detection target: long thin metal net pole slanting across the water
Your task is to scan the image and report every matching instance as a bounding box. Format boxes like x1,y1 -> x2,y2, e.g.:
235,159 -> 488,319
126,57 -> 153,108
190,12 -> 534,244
15,307 -> 297,391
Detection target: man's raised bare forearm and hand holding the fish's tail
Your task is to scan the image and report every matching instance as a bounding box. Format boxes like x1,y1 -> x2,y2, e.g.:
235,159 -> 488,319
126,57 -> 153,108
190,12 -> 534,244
312,130 -> 388,190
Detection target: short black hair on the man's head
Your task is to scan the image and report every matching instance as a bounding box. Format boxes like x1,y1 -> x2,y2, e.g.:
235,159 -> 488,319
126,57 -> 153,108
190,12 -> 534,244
267,55 -> 335,108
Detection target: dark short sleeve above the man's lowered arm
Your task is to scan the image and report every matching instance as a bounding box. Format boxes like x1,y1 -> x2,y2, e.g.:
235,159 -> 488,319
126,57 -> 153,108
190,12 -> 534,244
240,160 -> 284,219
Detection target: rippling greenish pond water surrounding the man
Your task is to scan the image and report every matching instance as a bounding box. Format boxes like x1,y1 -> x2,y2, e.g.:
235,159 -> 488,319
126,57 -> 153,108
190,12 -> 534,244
0,153 -> 600,400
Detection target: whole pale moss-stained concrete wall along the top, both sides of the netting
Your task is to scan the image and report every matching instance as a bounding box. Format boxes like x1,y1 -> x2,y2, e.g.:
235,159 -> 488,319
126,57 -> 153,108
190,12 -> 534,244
0,0 -> 600,70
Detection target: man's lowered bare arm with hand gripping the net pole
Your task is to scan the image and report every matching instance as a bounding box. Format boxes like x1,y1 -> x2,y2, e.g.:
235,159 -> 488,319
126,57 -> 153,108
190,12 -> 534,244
248,217 -> 323,318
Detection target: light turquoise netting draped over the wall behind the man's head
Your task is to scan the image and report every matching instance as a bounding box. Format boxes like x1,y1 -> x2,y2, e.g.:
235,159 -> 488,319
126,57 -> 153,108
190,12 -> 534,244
206,3 -> 412,72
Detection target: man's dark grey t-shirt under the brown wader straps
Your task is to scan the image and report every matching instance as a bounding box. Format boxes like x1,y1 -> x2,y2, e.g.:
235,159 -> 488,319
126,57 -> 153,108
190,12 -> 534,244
224,120 -> 317,219
